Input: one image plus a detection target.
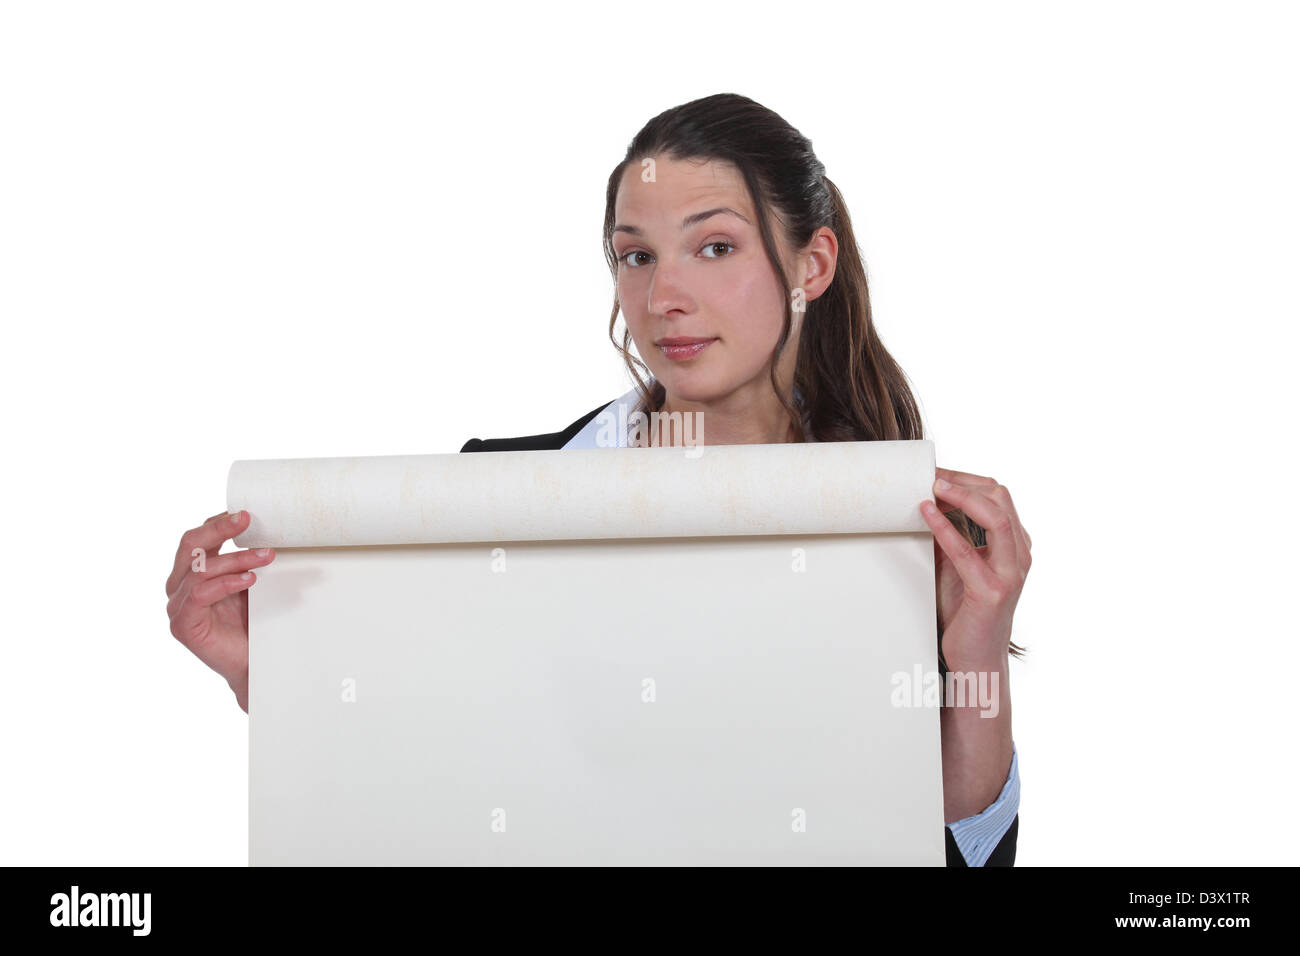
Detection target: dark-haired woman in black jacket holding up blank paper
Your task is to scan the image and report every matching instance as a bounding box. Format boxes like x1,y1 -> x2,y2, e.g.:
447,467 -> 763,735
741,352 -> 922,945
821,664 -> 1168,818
168,94 -> 1031,866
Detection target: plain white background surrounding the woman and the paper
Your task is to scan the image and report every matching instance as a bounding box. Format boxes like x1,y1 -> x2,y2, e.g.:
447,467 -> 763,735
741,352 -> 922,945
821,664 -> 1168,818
0,1 -> 1300,865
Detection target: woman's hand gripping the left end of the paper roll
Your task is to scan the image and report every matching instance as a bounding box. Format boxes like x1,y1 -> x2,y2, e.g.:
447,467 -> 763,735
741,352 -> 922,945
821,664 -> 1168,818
166,511 -> 276,713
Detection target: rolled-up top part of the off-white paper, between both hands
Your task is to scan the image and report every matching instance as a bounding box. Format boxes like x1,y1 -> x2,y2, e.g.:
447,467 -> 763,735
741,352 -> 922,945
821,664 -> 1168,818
226,441 -> 935,548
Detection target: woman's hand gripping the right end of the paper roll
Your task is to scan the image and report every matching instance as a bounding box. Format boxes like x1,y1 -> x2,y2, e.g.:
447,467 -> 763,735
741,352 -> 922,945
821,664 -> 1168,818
920,468 -> 1034,670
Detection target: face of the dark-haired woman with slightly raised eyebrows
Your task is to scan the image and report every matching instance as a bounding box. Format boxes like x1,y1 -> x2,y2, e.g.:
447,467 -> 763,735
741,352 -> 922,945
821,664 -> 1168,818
612,156 -> 805,405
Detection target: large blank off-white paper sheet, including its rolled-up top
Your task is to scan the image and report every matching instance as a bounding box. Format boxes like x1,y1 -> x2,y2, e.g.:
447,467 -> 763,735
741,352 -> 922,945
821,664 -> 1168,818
228,441 -> 944,865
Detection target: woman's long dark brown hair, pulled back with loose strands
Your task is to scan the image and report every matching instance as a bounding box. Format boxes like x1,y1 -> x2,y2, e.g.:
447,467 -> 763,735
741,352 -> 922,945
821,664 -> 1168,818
605,92 -> 1023,670
